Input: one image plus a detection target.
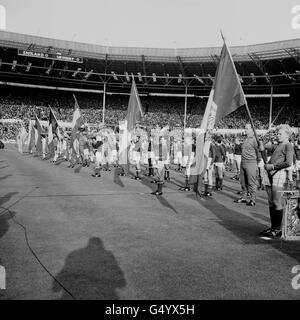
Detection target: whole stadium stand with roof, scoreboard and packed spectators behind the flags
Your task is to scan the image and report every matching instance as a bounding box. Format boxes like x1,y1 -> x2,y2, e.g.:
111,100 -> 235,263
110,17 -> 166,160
0,31 -> 300,139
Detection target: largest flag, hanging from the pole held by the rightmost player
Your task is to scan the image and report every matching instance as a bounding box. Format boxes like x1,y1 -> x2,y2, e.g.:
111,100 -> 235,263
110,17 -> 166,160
190,41 -> 246,191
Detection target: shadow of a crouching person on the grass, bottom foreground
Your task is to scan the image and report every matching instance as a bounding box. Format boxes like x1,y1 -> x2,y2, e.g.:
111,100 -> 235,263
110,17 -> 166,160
52,237 -> 126,300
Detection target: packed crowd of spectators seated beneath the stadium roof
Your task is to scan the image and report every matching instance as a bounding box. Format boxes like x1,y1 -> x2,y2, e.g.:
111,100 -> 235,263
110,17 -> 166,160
0,87 -> 299,139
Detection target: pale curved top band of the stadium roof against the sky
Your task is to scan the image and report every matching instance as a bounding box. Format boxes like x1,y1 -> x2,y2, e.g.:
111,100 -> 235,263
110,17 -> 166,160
0,31 -> 300,62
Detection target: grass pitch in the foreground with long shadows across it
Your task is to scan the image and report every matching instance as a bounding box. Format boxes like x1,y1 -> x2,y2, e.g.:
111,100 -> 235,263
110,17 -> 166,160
0,146 -> 300,300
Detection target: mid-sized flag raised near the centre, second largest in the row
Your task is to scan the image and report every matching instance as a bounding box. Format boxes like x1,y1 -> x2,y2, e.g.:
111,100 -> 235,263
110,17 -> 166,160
126,77 -> 144,131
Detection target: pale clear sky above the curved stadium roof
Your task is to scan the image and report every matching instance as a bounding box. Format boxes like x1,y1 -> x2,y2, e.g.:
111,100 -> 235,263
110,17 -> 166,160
0,0 -> 300,48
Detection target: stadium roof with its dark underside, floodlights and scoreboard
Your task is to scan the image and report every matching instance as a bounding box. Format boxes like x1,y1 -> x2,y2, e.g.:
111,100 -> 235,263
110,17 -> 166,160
0,31 -> 300,95
